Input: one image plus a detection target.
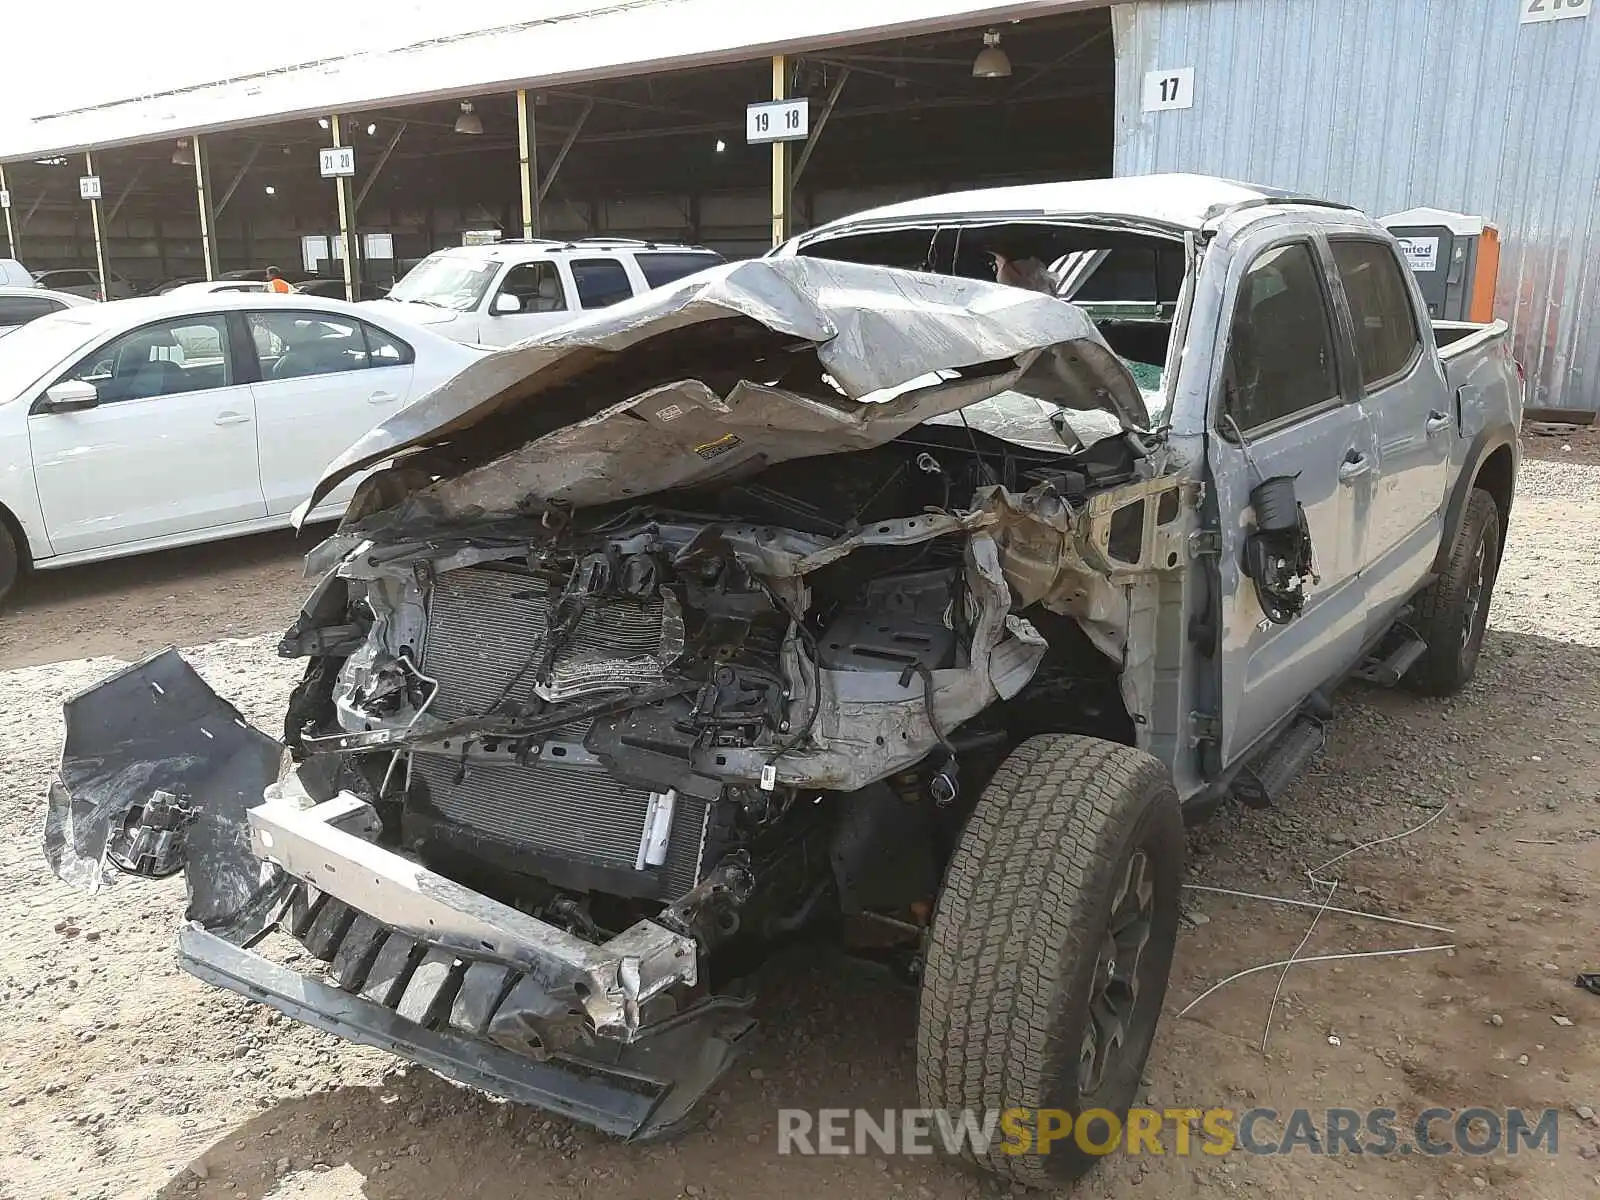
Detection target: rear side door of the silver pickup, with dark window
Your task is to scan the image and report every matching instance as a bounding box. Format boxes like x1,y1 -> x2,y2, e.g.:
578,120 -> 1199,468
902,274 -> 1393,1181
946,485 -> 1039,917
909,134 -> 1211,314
1328,235 -> 1456,632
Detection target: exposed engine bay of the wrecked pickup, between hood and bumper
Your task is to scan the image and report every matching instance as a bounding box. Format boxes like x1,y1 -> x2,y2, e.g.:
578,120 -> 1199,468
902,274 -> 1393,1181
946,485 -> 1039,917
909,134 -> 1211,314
286,426 -> 1177,944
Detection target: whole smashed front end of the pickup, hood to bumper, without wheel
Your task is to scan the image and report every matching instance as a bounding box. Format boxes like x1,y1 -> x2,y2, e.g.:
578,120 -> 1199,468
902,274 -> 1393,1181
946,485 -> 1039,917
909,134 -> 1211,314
40,259 -> 1197,1133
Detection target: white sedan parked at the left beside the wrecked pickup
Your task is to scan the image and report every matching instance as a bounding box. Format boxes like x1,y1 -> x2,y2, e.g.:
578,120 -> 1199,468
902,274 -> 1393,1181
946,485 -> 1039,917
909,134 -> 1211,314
0,293 -> 485,595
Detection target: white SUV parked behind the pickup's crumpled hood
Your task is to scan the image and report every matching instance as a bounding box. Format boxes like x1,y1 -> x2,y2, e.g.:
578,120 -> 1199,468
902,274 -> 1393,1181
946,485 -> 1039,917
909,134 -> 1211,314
365,237 -> 723,346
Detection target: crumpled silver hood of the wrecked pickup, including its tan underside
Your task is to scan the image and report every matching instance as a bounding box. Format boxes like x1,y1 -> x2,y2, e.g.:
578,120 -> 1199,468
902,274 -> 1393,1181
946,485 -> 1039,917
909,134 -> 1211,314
296,258 -> 1149,517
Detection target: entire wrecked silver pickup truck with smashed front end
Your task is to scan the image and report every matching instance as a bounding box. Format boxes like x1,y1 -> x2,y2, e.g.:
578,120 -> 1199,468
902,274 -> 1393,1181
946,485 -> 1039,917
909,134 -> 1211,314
46,179 -> 1520,1182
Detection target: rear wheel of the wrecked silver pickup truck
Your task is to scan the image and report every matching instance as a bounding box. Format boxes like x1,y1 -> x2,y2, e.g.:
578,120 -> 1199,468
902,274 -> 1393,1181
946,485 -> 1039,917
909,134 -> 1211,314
1405,488 -> 1501,696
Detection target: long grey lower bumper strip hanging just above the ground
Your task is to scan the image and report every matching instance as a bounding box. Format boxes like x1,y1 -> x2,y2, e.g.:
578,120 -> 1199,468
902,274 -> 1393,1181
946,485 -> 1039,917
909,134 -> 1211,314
178,923 -> 754,1139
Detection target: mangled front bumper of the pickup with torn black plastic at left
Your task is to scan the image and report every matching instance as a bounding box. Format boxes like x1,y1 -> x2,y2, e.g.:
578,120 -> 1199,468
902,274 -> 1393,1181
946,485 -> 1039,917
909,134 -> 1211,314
46,651 -> 754,1138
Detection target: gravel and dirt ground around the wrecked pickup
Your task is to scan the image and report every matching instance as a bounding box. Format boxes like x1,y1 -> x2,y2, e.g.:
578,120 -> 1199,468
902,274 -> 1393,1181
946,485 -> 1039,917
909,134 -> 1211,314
0,435 -> 1600,1200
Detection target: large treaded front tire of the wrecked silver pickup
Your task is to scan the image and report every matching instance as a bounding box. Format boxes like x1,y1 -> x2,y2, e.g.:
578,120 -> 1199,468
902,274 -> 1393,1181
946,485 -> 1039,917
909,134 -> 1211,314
917,734 -> 1184,1187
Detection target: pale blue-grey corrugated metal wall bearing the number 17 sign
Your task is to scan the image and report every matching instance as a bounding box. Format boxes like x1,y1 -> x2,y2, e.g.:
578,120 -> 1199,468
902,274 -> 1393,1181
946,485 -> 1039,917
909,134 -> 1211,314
1114,0 -> 1600,410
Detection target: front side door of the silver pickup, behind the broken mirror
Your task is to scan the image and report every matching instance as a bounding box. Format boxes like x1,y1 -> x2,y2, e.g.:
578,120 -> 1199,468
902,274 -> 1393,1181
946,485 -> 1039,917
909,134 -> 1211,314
1206,229 -> 1378,765
